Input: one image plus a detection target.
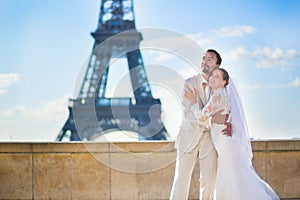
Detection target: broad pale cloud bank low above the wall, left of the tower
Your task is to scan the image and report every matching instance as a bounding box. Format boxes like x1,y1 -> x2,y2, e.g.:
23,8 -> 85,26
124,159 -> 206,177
0,95 -> 71,141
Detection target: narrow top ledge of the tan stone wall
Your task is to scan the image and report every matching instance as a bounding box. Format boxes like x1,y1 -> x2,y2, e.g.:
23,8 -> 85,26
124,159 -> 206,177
0,140 -> 300,153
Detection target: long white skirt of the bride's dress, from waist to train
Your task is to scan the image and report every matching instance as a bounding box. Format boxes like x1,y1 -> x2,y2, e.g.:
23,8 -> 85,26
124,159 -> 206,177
211,124 -> 279,200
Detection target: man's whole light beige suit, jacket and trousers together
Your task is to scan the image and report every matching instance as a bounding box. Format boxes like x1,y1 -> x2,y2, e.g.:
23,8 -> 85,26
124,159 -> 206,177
170,74 -> 217,200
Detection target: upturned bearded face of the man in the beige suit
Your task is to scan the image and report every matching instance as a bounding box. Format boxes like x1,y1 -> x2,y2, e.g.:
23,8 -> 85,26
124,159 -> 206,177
201,52 -> 219,75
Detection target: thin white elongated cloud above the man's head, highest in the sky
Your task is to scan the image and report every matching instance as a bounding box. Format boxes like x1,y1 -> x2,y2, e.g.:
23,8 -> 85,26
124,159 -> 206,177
213,26 -> 256,38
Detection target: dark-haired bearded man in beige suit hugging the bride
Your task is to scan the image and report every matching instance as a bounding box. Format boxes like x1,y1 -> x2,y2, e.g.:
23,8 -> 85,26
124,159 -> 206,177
170,49 -> 231,200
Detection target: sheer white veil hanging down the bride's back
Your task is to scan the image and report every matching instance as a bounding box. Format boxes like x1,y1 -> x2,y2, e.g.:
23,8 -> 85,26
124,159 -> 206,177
226,77 -> 253,162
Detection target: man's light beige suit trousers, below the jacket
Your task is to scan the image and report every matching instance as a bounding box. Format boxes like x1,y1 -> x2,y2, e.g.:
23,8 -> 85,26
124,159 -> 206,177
170,132 -> 217,200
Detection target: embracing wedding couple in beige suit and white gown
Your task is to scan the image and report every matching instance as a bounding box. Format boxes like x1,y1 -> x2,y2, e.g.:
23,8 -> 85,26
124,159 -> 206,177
170,49 -> 279,200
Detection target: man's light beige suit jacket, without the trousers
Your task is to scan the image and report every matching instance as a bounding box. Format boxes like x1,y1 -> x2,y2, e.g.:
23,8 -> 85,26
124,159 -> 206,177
175,74 -> 208,153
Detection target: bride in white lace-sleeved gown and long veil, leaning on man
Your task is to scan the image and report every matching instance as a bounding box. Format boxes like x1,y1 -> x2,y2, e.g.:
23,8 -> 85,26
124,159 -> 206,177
190,68 -> 279,200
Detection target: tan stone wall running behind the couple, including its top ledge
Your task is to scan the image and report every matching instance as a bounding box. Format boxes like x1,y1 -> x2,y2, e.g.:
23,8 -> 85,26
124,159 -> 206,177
0,140 -> 300,200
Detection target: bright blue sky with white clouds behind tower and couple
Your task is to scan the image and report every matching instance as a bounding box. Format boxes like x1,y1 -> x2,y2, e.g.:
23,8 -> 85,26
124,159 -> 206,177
0,0 -> 300,141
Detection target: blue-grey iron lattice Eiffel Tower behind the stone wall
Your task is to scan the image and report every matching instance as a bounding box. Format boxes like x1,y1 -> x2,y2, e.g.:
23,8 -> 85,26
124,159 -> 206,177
56,0 -> 168,141
